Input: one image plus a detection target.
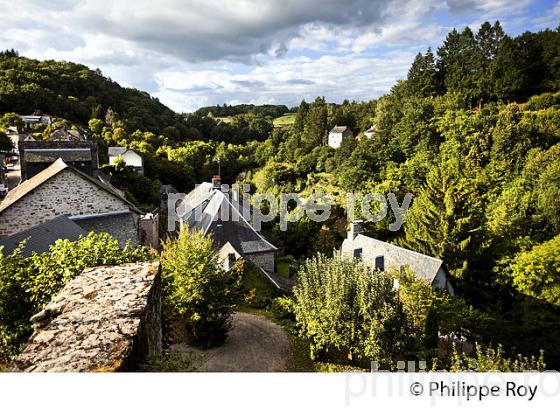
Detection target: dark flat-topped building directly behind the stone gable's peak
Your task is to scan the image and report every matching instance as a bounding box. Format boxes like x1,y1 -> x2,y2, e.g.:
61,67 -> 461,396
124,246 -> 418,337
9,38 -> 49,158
19,140 -> 99,181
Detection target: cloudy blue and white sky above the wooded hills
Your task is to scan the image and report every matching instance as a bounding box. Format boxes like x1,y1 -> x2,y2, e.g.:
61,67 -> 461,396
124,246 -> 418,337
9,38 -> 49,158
0,0 -> 560,112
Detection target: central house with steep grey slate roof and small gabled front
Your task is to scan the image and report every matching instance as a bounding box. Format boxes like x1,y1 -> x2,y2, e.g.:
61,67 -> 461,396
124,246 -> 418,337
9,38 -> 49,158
177,177 -> 290,288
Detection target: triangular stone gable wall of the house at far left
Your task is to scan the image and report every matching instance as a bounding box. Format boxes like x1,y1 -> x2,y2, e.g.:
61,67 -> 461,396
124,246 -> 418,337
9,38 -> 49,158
0,169 -> 129,238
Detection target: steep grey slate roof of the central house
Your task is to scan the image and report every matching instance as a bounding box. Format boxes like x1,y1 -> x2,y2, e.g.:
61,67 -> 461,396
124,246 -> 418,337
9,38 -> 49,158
179,182 -> 278,255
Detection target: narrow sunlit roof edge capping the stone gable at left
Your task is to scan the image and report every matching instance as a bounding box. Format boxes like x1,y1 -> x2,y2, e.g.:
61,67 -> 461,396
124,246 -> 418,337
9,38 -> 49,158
0,158 -> 142,214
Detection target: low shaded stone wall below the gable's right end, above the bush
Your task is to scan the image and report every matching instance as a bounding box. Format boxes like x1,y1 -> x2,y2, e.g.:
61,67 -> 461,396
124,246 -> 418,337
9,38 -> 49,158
71,211 -> 139,247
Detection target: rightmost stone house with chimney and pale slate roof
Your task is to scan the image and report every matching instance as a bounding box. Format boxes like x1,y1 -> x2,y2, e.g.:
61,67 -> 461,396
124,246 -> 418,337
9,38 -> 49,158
341,221 -> 455,295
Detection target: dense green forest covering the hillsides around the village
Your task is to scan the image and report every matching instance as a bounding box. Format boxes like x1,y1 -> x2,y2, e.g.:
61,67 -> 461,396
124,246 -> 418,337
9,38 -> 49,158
0,22 -> 560,368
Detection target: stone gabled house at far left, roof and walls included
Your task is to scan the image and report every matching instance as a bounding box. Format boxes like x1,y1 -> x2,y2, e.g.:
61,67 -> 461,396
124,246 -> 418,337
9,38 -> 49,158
0,159 -> 141,240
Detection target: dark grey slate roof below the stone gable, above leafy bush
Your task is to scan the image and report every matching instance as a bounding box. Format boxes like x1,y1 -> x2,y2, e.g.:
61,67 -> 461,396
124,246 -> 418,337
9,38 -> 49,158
0,216 -> 87,258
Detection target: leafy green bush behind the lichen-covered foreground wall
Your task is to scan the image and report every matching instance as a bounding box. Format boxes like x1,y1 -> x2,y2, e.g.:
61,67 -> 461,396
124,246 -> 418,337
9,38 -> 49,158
0,233 -> 152,358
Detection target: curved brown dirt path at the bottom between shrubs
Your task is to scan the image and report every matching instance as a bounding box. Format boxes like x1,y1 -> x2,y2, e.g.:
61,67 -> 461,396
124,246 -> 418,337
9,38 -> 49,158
171,312 -> 290,372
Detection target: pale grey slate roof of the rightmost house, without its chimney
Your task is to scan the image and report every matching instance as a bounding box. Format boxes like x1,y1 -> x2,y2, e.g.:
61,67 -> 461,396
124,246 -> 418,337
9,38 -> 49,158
342,234 -> 443,283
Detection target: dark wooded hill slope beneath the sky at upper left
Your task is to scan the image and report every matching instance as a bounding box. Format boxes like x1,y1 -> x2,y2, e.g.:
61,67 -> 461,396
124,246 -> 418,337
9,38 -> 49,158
0,53 -> 188,135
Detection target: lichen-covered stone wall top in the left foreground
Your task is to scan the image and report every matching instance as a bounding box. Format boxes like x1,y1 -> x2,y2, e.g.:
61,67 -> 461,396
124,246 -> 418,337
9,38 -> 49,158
15,262 -> 162,372
